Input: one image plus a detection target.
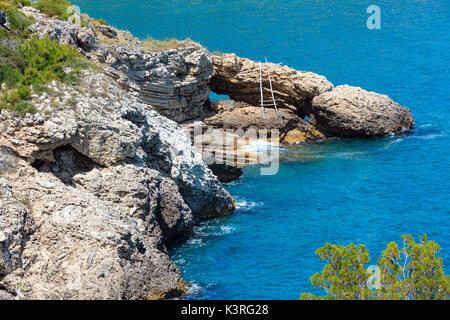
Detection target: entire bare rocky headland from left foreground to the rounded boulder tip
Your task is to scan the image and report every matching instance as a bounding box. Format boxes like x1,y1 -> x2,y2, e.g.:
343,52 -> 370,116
0,7 -> 414,299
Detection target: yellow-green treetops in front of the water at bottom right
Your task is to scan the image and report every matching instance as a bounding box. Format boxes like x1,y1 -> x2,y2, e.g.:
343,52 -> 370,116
300,235 -> 450,300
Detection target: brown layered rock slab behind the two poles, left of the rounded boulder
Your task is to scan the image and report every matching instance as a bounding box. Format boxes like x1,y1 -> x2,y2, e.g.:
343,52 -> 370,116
211,54 -> 333,118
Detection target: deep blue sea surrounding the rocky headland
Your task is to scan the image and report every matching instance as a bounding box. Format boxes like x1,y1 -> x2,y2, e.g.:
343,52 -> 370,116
72,0 -> 450,299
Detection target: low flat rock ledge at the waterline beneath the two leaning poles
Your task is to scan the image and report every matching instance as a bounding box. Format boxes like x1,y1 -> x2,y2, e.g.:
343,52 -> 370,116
181,100 -> 326,182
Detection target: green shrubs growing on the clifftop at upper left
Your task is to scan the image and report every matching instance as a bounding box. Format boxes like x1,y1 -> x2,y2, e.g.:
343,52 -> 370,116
0,0 -> 88,114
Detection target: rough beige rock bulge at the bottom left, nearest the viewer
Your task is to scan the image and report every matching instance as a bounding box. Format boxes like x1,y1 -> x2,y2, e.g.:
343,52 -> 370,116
0,163 -> 184,299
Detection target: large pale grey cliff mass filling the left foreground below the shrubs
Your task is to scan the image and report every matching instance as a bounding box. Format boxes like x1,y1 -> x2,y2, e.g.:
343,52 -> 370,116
0,70 -> 234,299
